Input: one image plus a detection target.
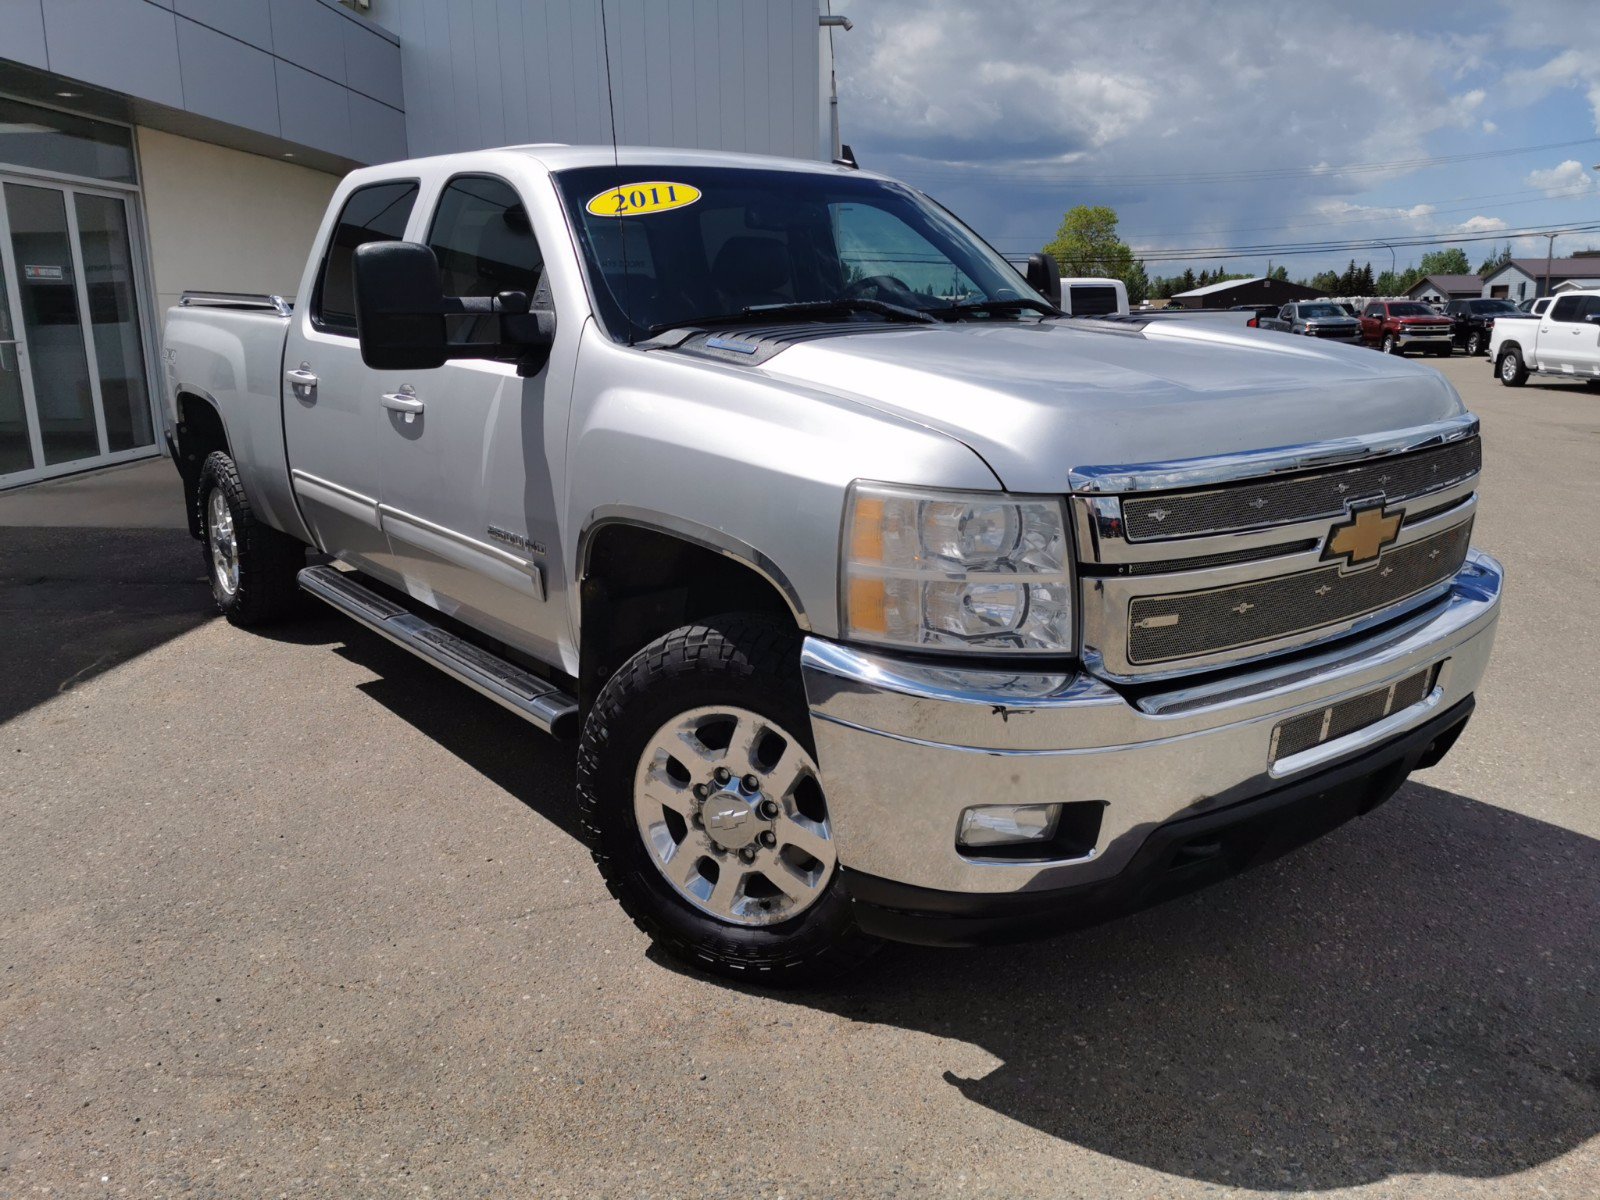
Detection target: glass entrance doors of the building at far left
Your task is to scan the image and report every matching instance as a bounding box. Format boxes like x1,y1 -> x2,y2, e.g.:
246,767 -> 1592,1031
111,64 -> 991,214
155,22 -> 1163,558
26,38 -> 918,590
0,176 -> 155,486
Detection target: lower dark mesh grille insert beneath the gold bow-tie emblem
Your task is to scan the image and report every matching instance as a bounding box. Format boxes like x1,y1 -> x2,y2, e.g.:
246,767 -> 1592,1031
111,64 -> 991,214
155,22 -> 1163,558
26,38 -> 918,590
1128,518 -> 1472,666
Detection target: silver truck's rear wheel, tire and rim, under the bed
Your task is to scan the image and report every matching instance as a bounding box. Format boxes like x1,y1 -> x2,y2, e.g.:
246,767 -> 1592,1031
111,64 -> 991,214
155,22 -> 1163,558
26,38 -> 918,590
195,450 -> 306,627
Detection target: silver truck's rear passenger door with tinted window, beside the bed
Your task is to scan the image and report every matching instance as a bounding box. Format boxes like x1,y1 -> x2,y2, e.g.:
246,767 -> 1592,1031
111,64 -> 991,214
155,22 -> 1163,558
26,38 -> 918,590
283,179 -> 418,579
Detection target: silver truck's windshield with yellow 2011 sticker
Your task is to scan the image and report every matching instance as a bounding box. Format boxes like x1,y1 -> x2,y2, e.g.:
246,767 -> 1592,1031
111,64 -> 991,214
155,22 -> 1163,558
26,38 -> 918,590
554,163 -> 1050,341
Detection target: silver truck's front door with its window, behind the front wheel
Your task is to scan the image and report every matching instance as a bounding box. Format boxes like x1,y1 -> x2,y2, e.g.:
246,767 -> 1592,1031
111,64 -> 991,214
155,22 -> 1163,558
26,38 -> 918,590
373,174 -> 576,656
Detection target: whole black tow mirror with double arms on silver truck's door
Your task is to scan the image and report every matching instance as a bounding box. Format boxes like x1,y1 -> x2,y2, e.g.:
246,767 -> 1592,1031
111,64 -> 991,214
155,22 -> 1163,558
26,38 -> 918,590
355,242 -> 555,376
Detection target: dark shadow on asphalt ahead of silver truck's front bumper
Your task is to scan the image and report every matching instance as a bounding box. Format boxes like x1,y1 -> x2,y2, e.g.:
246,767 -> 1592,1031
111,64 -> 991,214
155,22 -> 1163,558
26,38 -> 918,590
777,784 -> 1600,1190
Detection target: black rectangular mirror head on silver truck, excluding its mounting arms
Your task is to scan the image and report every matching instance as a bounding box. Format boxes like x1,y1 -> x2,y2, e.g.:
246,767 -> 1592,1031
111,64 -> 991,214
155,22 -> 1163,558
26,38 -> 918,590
355,242 -> 450,371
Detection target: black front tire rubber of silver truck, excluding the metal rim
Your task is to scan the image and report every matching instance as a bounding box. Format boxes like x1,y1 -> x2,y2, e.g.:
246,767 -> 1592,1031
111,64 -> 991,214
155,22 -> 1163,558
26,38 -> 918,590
578,614 -> 880,987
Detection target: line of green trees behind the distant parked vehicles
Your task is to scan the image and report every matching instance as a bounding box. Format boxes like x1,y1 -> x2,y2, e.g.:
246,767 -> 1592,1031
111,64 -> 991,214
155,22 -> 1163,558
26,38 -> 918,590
1045,205 -> 1512,304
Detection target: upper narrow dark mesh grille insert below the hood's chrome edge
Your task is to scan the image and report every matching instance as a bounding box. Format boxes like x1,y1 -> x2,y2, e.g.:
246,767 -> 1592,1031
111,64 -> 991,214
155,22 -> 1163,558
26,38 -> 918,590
1122,437 -> 1482,542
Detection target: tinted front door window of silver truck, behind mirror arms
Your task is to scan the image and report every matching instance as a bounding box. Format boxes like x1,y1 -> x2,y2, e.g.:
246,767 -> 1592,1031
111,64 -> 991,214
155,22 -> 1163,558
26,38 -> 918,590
427,174 -> 544,342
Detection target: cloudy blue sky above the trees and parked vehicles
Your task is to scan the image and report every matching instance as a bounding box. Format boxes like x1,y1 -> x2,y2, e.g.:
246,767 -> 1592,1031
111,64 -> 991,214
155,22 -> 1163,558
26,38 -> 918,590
830,0 -> 1600,278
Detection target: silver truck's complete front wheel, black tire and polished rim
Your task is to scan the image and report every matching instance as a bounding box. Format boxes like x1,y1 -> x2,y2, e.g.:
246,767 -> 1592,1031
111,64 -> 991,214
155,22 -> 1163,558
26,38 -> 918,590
578,614 -> 877,984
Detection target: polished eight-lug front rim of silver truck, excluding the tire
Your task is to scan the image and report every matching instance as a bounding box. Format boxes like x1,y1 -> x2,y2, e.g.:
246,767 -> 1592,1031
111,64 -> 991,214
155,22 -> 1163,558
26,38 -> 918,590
634,706 -> 837,926
